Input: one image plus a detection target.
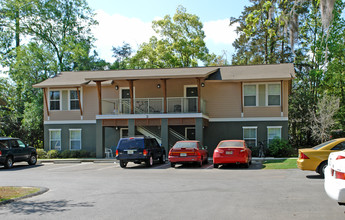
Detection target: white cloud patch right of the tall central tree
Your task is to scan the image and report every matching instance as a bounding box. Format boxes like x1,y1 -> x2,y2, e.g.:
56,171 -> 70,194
204,19 -> 238,45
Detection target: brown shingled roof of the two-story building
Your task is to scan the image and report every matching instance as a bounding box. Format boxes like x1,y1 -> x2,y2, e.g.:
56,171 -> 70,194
34,64 -> 295,88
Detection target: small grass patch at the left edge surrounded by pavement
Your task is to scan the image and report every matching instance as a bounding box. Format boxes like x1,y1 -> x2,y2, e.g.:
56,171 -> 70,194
0,186 -> 40,202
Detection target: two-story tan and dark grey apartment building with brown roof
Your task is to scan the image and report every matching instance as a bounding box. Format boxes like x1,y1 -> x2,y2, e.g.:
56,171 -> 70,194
34,64 -> 295,157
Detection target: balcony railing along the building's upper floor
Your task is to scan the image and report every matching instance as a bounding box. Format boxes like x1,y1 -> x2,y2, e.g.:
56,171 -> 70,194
102,97 -> 206,115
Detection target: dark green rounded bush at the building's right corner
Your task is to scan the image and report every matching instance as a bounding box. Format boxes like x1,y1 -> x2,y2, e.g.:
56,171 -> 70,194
267,138 -> 294,157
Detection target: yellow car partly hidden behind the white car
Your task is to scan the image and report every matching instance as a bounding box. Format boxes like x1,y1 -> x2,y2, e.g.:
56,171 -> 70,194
297,138 -> 345,176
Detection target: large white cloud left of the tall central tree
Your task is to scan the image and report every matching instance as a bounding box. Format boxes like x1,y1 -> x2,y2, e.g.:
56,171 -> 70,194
92,10 -> 155,62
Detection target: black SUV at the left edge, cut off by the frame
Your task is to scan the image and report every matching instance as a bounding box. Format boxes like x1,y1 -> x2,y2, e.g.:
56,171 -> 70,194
0,137 -> 37,168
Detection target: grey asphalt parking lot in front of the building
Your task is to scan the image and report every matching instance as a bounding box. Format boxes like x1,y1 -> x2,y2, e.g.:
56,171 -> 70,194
0,162 -> 345,219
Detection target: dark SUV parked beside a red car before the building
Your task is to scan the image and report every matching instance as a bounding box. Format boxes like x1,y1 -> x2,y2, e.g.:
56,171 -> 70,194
116,137 -> 166,168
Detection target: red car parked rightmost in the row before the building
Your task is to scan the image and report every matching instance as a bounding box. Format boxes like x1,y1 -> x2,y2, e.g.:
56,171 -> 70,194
213,140 -> 252,168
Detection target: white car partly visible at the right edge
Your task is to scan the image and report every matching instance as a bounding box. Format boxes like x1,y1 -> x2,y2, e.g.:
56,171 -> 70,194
325,151 -> 345,205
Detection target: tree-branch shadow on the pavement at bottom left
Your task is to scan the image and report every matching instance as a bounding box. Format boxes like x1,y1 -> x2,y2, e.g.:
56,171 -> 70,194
0,200 -> 94,216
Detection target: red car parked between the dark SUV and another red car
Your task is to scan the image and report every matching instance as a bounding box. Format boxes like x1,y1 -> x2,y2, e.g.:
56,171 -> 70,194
169,141 -> 208,167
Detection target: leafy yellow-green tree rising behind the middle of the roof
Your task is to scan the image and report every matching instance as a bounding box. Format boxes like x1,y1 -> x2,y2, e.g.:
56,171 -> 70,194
131,6 -> 208,68
